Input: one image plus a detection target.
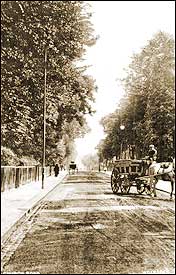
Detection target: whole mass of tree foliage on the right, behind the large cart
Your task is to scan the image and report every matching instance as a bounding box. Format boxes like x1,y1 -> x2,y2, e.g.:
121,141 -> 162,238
101,32 -> 175,161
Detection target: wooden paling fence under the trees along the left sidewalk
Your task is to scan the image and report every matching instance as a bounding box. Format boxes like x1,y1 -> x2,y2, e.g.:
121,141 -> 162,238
1,166 -> 53,192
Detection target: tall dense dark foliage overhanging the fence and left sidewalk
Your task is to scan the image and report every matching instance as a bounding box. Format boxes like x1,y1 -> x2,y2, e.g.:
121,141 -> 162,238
1,1 -> 96,164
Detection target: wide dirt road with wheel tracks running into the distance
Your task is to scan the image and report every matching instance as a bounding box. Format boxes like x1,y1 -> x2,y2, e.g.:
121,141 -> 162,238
1,172 -> 175,274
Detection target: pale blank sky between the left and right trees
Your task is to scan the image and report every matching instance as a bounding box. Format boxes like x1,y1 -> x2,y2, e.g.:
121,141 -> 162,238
75,1 -> 175,166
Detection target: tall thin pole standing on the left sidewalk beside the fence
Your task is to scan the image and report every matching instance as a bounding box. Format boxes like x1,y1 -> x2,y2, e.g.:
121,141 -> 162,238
42,47 -> 47,189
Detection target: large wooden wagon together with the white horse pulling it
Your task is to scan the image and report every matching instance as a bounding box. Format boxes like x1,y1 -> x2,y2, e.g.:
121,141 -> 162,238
111,159 -> 174,198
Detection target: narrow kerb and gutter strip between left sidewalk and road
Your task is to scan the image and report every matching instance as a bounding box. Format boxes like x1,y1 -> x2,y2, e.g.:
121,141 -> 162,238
1,173 -> 68,245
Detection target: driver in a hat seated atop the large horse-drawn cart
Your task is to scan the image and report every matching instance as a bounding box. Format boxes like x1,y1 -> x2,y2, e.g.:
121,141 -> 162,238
142,144 -> 157,176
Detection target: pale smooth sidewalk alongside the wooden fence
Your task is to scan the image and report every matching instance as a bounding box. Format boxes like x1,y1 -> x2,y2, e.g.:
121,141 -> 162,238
1,171 -> 67,238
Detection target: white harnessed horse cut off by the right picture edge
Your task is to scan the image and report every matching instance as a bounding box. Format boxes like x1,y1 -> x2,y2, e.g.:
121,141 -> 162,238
149,159 -> 175,199
